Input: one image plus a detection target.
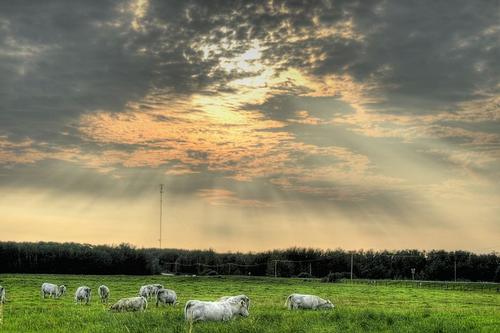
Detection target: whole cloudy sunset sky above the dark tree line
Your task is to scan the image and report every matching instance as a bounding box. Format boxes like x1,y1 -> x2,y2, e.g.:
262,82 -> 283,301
0,0 -> 500,252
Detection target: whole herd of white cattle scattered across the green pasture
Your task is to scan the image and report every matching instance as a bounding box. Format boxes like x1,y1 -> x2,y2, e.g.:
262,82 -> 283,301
0,282 -> 334,322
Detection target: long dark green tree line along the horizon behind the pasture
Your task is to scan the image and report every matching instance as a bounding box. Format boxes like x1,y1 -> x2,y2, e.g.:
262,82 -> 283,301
0,242 -> 500,282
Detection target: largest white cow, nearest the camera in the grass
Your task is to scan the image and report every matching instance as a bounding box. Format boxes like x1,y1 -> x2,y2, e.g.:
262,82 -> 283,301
184,300 -> 249,322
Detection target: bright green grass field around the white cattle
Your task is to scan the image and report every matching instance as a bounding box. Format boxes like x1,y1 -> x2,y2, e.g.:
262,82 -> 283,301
0,275 -> 500,333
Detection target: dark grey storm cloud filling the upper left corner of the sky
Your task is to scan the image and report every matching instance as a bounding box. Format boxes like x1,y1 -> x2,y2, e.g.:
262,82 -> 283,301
0,1 -> 241,140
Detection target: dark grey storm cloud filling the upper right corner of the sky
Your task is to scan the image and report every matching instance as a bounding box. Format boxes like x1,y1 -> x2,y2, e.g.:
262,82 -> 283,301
316,1 -> 500,113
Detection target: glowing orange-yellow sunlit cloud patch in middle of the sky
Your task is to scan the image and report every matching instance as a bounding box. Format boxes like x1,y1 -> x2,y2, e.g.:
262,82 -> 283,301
80,65 -> 368,184
